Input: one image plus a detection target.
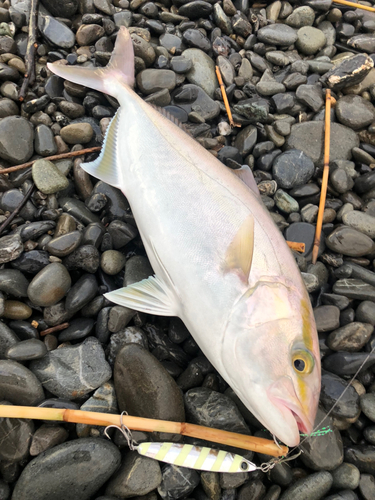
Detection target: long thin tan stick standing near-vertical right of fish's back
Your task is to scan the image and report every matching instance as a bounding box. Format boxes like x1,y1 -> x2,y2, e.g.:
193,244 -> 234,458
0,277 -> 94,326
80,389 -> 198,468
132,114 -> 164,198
312,89 -> 331,264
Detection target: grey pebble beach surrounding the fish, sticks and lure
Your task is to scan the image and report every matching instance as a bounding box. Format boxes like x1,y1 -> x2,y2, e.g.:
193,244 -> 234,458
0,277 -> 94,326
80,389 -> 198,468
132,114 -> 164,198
0,0 -> 375,500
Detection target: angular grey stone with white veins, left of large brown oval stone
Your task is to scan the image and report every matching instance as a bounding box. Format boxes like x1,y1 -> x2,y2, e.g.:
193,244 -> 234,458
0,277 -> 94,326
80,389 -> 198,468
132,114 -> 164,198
30,337 -> 112,399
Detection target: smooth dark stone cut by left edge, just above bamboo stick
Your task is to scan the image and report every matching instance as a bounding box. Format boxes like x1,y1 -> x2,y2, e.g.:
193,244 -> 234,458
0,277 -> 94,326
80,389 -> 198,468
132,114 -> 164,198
0,360 -> 44,406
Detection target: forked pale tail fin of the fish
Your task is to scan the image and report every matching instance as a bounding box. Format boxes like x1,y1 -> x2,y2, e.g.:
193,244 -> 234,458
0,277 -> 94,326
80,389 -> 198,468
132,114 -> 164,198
47,26 -> 134,97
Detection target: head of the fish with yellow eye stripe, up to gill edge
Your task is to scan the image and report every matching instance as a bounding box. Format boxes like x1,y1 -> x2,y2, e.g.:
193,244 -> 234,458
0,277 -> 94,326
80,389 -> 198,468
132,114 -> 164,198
222,280 -> 321,446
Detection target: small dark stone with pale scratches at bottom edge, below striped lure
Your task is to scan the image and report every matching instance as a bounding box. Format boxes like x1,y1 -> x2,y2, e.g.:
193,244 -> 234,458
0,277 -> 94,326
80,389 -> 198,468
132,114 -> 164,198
158,464 -> 201,500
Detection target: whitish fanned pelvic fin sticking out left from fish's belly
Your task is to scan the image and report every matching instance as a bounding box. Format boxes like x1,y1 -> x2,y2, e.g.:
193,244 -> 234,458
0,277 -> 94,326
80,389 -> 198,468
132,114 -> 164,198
105,276 -> 179,316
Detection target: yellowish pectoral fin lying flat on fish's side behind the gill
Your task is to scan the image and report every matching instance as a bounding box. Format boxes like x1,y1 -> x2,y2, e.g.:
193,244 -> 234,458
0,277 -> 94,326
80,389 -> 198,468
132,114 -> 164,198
225,215 -> 254,282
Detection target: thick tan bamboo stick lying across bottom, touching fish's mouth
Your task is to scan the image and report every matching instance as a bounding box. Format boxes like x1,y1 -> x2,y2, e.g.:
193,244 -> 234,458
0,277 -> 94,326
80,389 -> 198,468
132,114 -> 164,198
0,405 -> 289,457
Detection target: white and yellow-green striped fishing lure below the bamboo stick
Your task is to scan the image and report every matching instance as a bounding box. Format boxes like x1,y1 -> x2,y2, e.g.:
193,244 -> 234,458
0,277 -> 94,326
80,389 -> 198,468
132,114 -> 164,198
134,443 -> 257,473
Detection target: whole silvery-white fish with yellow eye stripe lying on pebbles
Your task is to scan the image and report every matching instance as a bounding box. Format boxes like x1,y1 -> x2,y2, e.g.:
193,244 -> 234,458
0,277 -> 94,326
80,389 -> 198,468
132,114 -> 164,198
48,27 -> 320,446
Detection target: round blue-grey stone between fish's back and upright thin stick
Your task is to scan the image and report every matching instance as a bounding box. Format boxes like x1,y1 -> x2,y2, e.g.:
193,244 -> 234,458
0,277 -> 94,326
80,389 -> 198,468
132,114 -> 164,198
272,149 -> 314,189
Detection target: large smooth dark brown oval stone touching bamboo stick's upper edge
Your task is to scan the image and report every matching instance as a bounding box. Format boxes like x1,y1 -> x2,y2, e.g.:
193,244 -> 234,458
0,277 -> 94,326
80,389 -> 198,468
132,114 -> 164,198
114,344 -> 185,430
